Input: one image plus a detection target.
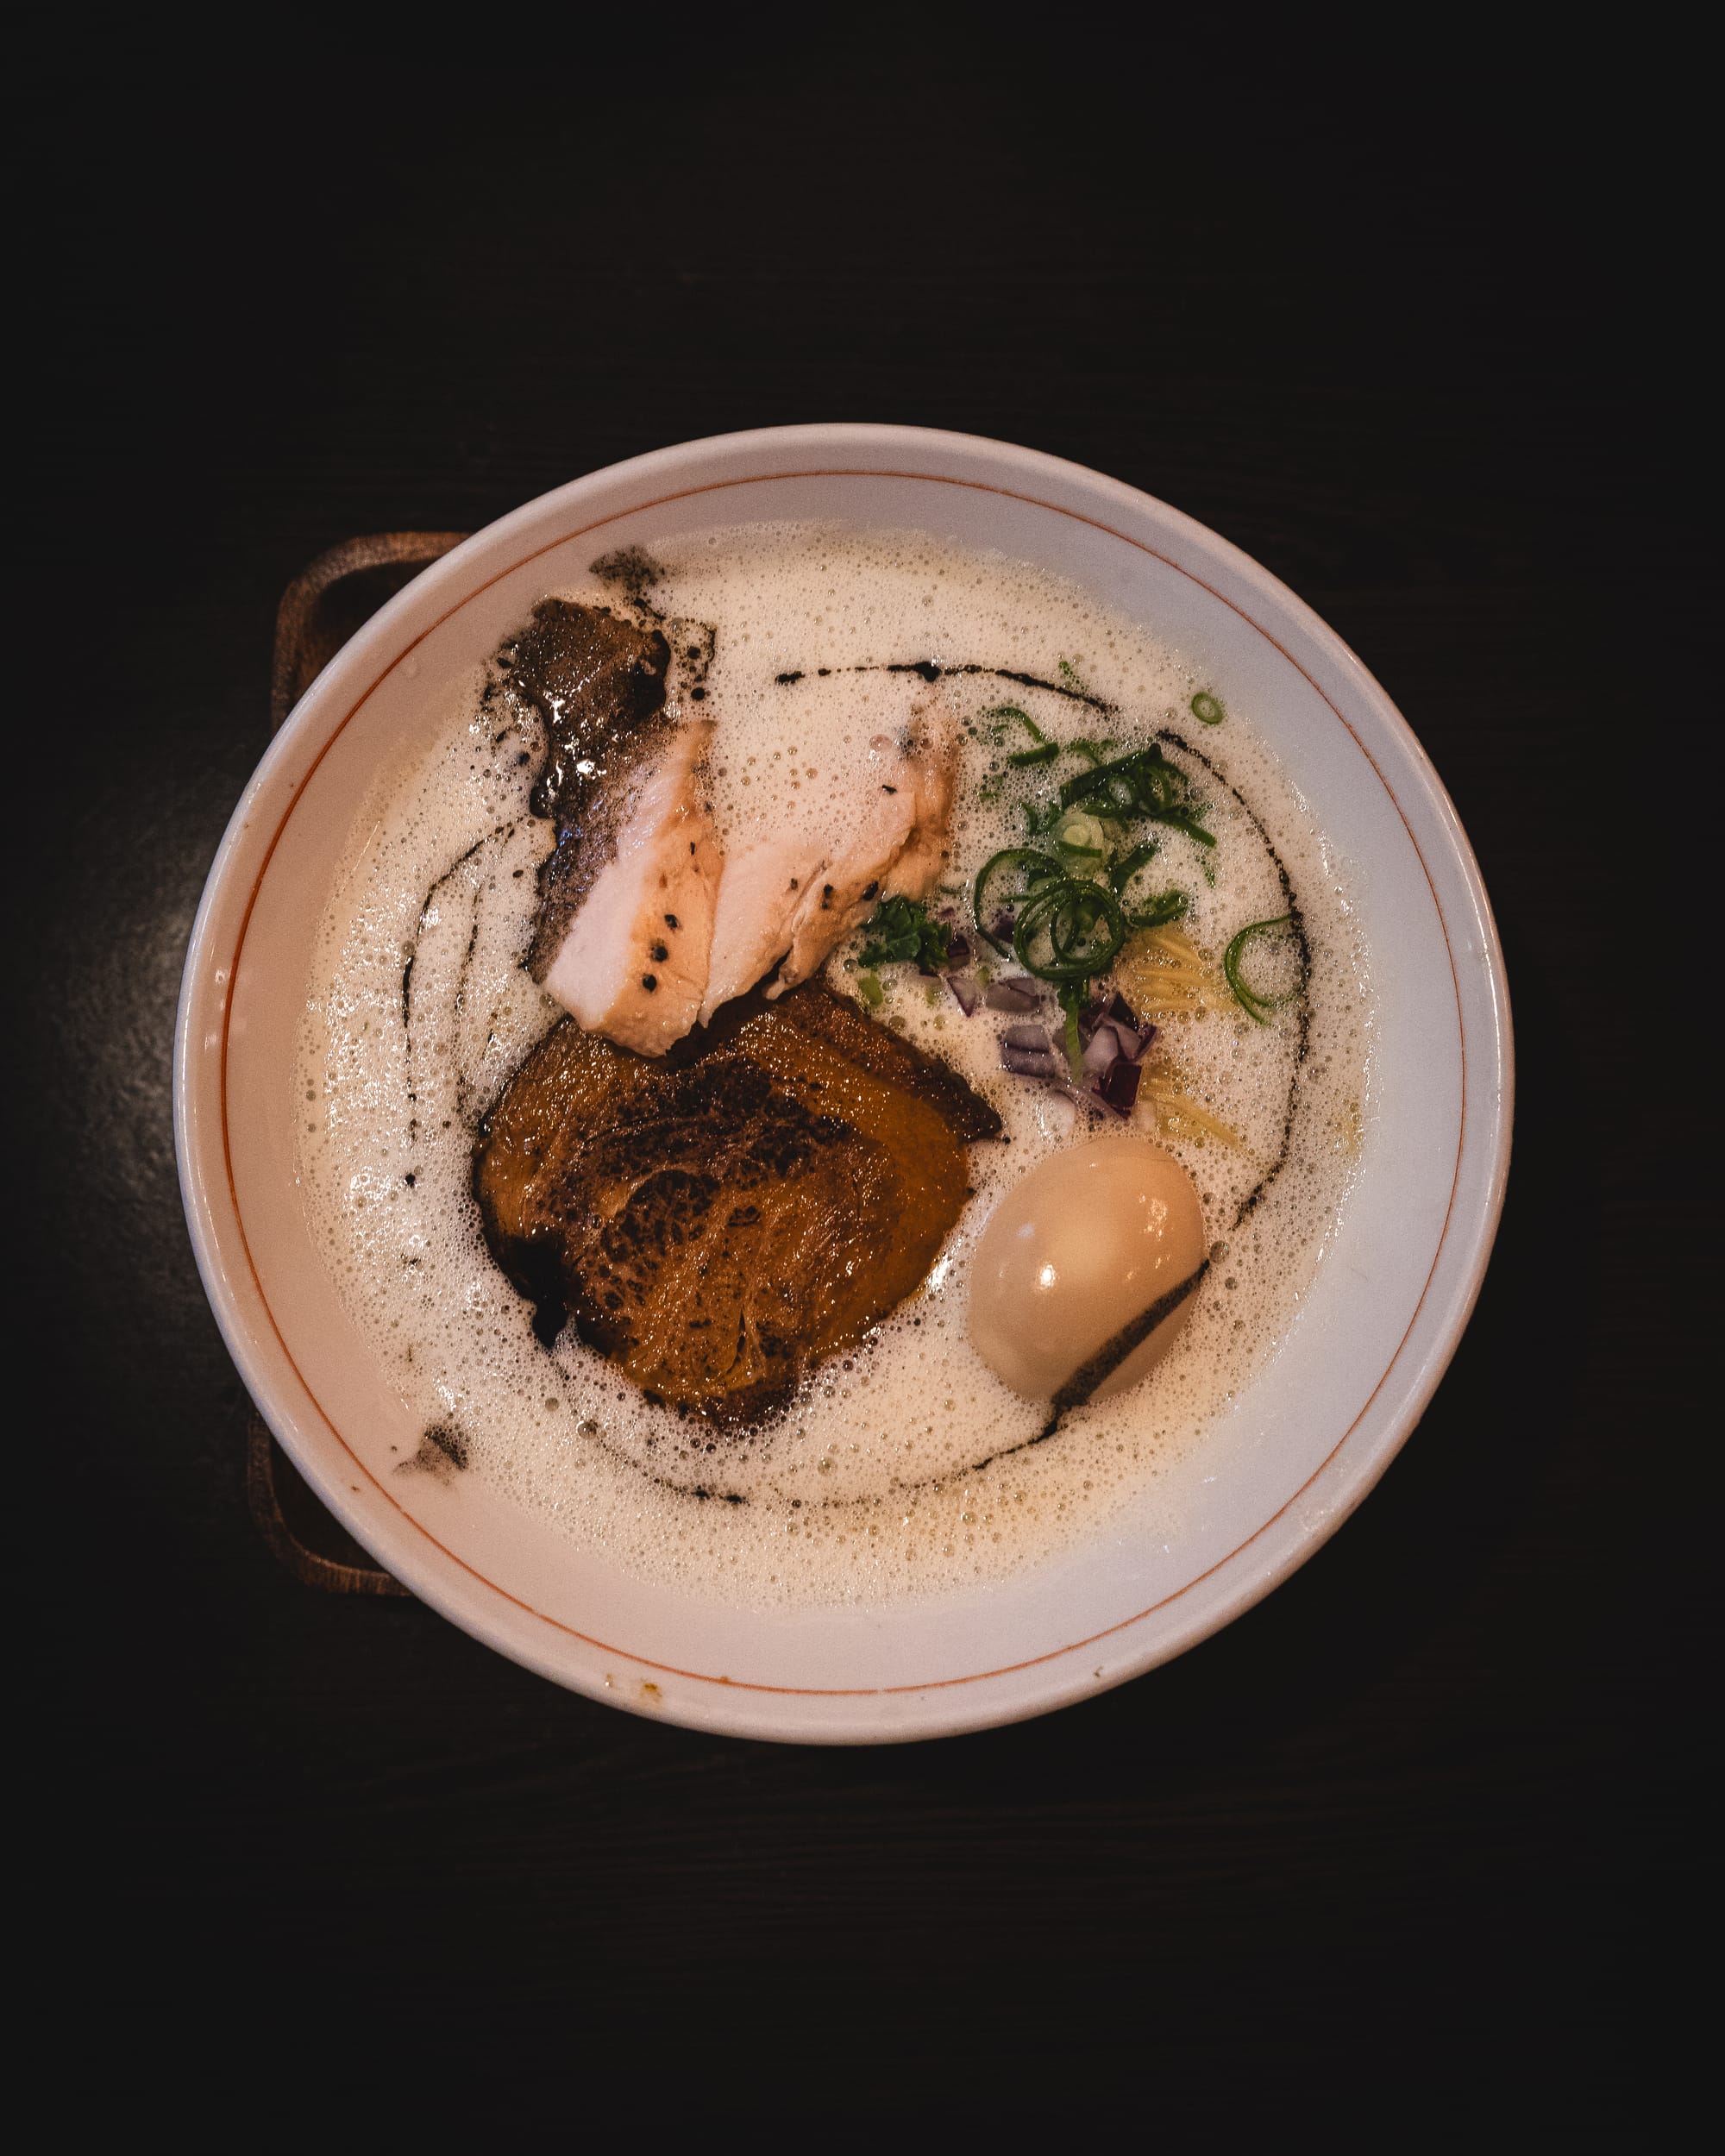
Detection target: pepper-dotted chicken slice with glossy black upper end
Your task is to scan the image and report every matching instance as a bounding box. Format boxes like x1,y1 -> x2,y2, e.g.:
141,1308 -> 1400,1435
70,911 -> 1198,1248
515,599 -> 720,1056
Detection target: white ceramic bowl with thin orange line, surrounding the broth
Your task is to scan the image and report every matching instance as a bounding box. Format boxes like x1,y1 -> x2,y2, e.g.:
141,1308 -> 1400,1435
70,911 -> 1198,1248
175,427 -> 1512,1745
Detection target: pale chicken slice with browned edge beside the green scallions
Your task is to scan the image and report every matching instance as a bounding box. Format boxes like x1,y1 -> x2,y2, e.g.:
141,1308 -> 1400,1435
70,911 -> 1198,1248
759,697 -> 957,996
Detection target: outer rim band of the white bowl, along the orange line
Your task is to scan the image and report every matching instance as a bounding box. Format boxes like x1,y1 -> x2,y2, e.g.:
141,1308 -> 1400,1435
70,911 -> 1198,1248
175,423 -> 1514,1742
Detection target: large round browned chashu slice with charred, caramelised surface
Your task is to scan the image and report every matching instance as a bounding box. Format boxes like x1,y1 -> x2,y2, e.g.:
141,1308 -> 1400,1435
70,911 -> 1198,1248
474,986 -> 1000,1427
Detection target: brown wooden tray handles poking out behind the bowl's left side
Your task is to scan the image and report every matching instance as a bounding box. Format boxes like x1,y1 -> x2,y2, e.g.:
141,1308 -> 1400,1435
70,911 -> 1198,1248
246,533 -> 468,1595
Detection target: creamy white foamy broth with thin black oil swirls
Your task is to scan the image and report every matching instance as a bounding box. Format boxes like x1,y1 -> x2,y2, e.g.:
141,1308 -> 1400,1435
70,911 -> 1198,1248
298,526 -> 1371,1604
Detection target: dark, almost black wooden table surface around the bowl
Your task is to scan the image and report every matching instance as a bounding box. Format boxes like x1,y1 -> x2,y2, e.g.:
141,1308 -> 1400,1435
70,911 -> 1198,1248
23,38 -> 1719,2139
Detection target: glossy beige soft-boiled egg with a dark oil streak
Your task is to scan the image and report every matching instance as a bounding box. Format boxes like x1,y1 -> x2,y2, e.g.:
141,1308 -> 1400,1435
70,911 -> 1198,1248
970,1138 -> 1208,1400
